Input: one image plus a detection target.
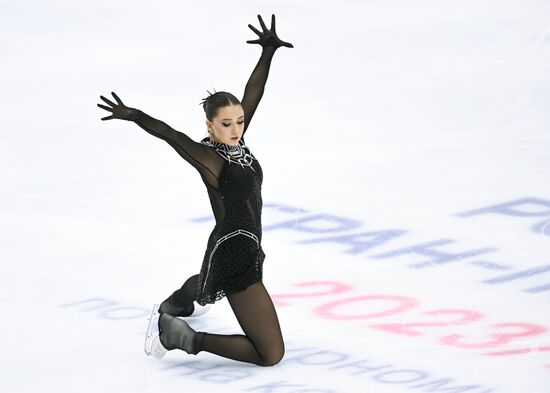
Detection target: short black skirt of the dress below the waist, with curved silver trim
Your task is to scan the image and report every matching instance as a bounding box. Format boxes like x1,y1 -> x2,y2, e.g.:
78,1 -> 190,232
195,228 -> 265,306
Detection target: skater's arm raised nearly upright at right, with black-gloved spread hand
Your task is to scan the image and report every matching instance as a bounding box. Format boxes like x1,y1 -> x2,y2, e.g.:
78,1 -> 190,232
241,14 -> 294,135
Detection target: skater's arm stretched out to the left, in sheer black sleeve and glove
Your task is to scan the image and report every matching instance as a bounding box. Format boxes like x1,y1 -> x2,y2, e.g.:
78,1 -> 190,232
97,92 -> 212,171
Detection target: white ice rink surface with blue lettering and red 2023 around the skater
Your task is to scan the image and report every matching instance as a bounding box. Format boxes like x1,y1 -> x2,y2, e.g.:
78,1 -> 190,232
0,0 -> 550,393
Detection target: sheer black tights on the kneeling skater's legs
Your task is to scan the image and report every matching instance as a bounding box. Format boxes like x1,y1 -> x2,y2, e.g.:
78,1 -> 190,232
162,275 -> 285,366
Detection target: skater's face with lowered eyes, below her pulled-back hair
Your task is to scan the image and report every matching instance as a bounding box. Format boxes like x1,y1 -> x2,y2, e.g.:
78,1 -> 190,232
206,104 -> 244,145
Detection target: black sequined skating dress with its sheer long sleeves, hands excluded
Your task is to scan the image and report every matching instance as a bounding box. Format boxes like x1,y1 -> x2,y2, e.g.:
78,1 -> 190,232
134,47 -> 275,306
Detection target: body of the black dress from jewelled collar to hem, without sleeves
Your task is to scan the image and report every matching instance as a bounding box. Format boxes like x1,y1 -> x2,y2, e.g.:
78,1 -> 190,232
195,138 -> 265,305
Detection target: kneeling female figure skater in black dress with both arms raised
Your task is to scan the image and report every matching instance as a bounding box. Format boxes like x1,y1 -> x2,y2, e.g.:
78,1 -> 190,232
97,14 -> 294,366
